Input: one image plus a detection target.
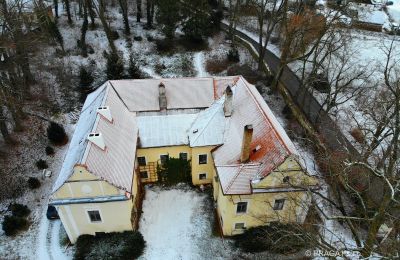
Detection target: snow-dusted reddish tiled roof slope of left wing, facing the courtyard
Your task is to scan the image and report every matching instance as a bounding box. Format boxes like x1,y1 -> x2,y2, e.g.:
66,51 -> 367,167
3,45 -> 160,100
81,84 -> 138,192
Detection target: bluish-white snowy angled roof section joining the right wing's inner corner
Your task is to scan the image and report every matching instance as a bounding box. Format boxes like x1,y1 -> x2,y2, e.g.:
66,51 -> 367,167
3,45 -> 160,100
188,96 -> 229,147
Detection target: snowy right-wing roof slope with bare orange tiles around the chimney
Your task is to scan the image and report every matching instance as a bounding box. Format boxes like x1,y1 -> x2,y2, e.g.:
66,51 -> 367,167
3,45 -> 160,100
213,78 -> 296,194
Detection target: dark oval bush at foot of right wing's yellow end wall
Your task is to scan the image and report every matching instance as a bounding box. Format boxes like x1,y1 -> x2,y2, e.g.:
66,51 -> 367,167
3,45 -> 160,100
234,223 -> 312,254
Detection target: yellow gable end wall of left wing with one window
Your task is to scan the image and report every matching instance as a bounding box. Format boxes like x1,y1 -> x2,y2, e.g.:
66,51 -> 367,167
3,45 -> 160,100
53,166 -> 137,243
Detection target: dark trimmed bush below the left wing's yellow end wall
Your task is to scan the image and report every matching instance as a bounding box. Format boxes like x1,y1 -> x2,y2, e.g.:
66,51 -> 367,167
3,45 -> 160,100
74,231 -> 146,260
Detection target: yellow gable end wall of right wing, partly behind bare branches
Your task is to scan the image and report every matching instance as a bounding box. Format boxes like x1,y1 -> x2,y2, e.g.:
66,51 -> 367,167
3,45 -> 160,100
213,155 -> 317,236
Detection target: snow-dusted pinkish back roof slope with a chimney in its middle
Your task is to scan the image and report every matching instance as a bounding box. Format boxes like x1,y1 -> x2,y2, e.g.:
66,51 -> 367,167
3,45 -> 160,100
110,78 -> 214,112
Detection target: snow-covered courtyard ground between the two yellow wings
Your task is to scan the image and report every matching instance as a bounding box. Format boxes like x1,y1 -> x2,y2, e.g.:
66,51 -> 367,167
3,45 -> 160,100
139,185 -> 238,260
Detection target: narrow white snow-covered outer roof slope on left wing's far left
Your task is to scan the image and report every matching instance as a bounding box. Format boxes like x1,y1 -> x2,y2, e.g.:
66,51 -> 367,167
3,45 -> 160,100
53,83 -> 107,192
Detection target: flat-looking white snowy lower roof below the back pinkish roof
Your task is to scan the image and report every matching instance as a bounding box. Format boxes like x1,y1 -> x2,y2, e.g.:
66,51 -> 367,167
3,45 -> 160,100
137,114 -> 197,148
